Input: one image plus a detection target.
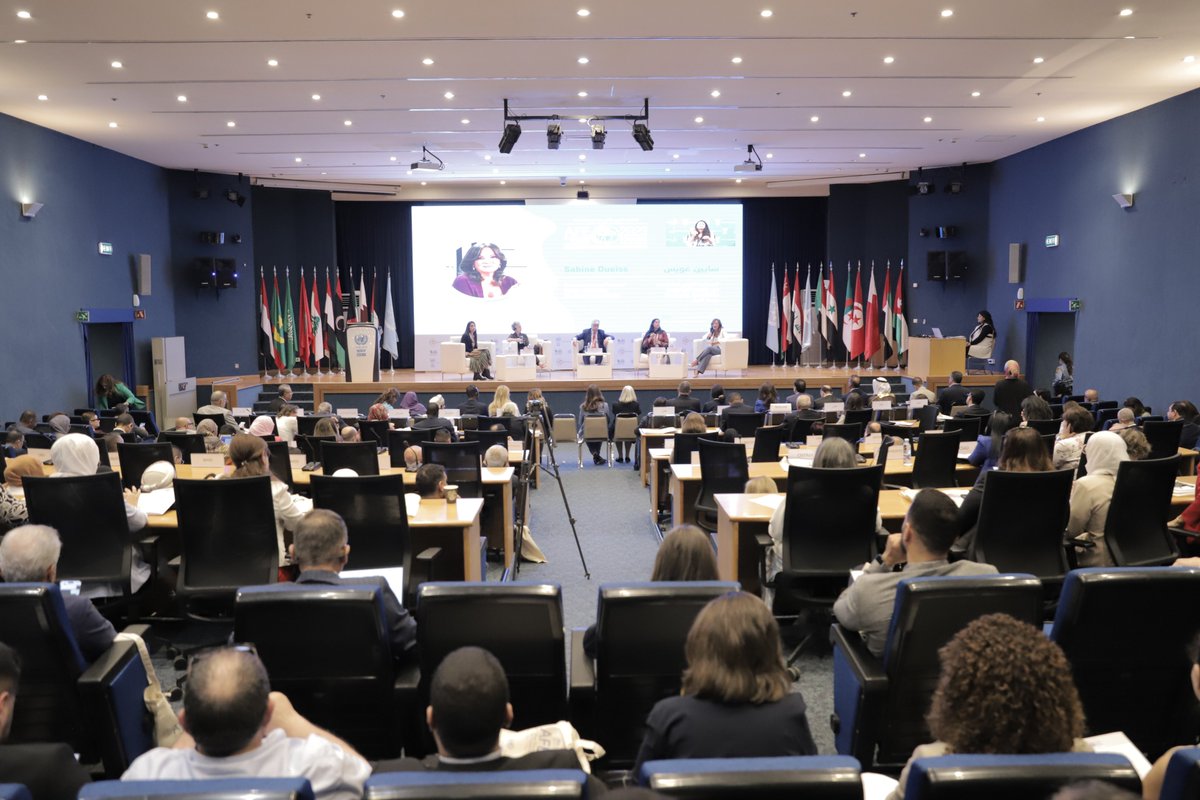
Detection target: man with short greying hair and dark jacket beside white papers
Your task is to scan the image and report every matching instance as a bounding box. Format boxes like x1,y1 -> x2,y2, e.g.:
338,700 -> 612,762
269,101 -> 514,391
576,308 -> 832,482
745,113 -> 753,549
289,509 -> 416,661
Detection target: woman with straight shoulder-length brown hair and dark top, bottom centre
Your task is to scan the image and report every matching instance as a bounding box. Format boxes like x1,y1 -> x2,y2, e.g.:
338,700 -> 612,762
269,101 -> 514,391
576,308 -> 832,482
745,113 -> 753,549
634,591 -> 817,772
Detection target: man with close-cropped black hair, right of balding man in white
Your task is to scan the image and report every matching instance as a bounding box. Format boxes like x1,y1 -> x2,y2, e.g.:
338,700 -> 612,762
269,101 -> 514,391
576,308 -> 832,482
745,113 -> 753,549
376,648 -> 604,796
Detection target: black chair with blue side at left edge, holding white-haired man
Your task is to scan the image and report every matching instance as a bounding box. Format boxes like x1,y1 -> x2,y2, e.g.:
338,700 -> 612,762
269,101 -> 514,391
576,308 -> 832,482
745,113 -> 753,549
0,585 -> 154,777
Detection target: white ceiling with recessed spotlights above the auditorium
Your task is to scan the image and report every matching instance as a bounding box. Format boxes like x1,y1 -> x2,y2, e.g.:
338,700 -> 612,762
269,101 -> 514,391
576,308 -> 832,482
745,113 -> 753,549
0,0 -> 1200,197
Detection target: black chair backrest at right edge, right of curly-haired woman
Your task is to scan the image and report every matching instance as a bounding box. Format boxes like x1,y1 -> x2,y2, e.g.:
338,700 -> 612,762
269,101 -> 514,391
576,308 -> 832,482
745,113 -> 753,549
1050,567 -> 1200,756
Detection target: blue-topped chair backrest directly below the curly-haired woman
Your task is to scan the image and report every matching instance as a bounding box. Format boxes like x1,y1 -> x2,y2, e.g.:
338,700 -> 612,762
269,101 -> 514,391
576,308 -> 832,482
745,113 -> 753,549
904,753 -> 1141,800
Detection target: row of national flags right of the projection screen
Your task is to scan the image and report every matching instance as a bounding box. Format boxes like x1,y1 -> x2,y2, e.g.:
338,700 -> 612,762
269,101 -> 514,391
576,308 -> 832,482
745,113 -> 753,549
767,261 -> 908,361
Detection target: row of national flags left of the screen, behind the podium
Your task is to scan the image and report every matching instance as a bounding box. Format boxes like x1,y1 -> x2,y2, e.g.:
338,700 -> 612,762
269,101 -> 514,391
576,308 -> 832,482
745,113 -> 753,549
258,266 -> 400,372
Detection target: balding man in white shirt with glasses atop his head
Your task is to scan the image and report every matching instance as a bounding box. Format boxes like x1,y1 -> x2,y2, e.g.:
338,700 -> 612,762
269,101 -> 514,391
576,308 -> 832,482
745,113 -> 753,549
121,646 -> 371,800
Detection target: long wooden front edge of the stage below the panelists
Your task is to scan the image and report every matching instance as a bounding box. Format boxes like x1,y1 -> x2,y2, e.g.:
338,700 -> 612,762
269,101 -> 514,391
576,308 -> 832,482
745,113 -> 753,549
197,366 -> 1002,396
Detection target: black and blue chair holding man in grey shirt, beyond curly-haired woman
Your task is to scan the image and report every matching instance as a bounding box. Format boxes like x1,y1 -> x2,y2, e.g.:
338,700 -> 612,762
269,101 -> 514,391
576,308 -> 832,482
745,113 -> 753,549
830,575 -> 1042,771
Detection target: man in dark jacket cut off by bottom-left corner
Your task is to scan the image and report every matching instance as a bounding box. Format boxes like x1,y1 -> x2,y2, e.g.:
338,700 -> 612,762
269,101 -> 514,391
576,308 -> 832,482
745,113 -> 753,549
0,644 -> 91,800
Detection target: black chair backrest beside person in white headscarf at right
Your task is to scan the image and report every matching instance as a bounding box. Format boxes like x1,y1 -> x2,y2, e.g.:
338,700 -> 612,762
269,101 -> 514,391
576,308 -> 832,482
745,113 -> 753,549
1104,456 -> 1180,566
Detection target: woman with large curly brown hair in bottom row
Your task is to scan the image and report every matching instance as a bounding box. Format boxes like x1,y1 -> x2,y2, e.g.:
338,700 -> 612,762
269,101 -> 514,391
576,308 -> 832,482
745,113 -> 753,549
888,614 -> 1091,800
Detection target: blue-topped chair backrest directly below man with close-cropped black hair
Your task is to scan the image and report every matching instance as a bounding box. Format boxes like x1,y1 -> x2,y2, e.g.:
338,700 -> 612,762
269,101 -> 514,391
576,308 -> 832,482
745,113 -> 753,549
362,770 -> 587,800
